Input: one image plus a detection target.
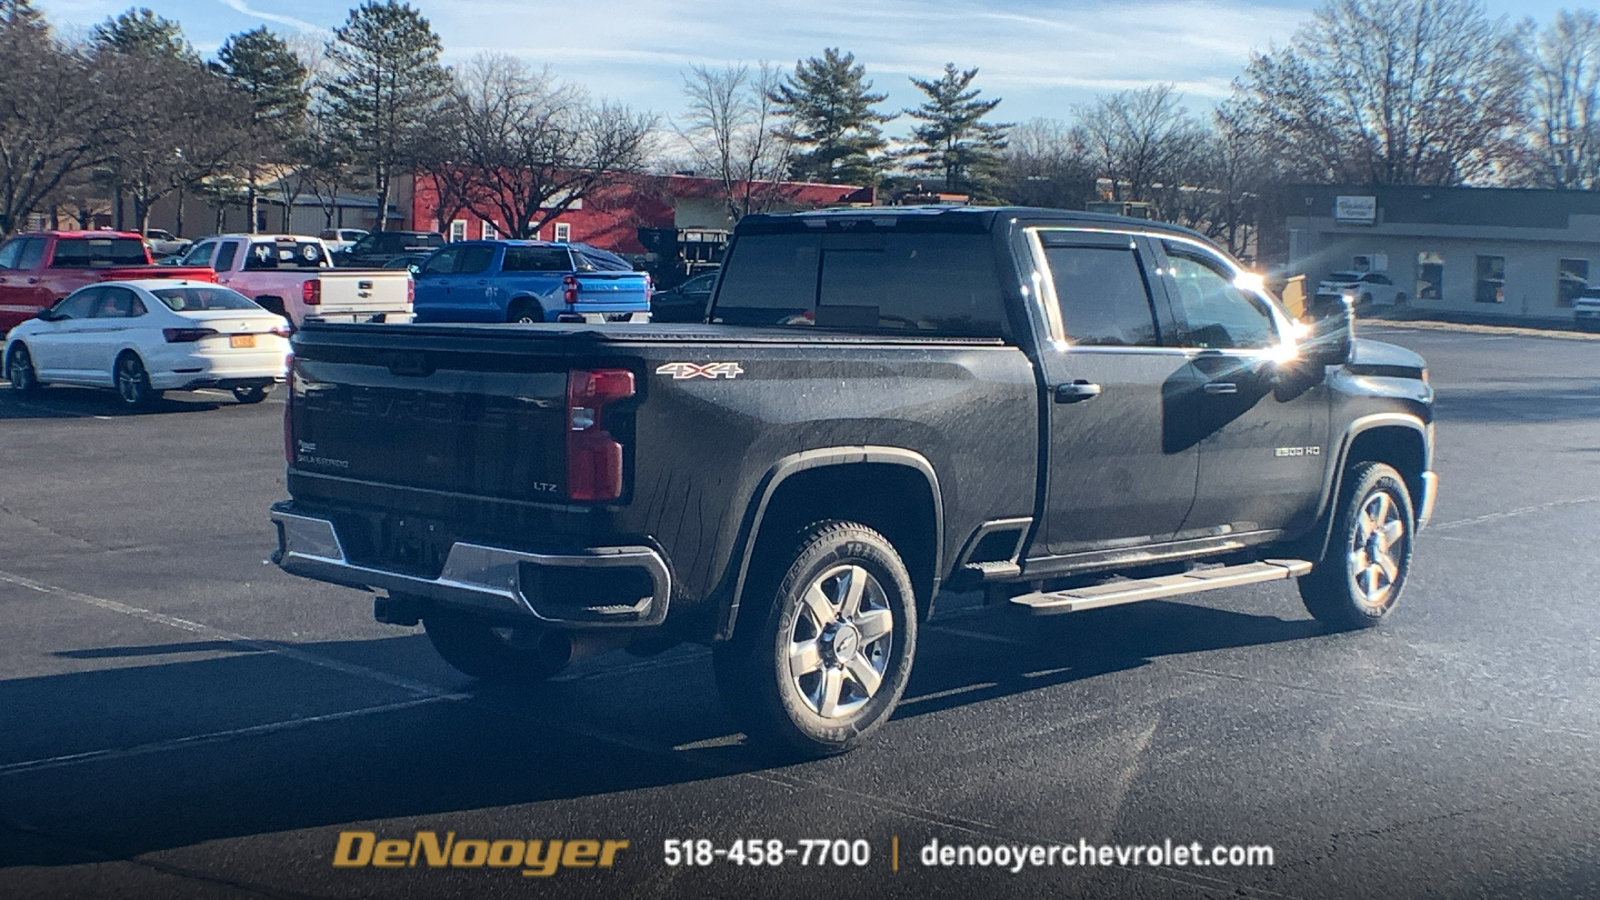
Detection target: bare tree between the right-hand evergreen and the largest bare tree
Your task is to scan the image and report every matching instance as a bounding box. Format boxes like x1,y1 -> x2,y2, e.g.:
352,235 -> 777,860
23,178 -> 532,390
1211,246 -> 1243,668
1074,83 -> 1205,202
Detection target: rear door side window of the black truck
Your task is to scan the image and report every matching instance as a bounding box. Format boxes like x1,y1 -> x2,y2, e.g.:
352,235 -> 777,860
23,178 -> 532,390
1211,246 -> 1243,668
1045,242 -> 1162,348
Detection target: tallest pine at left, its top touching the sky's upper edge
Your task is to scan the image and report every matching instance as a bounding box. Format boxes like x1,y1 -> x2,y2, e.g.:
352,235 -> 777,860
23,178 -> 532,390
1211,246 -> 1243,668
323,0 -> 451,231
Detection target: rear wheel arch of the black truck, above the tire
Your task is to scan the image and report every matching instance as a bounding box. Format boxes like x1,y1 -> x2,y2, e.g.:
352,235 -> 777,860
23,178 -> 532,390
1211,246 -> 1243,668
715,447 -> 944,641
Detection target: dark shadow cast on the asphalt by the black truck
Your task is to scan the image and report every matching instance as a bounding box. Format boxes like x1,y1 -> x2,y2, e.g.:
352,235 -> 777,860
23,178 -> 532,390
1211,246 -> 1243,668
0,602 -> 1320,868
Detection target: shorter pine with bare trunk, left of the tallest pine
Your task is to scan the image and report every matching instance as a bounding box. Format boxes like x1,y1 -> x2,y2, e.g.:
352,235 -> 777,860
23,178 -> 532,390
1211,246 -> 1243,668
211,27 -> 309,232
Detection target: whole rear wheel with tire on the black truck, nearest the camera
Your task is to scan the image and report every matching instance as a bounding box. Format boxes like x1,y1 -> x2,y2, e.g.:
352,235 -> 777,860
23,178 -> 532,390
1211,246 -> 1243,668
712,520 -> 917,757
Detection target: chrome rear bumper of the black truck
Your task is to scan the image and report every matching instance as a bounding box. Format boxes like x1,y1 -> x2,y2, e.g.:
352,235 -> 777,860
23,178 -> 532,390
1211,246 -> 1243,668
272,509 -> 672,628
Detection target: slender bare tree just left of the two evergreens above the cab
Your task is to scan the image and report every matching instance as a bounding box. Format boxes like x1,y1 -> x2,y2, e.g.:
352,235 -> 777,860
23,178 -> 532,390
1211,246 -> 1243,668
677,62 -> 794,221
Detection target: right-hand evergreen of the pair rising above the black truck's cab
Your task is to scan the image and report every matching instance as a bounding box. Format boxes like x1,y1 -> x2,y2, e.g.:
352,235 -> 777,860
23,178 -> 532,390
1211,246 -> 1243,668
906,62 -> 1011,200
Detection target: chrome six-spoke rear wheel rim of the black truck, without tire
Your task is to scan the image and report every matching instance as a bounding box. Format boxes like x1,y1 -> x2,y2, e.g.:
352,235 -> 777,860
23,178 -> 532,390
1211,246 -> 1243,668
789,565 -> 894,719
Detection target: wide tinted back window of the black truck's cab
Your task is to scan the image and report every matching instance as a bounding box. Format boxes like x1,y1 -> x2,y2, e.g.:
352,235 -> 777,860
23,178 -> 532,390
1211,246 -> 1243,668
715,231 -> 1005,338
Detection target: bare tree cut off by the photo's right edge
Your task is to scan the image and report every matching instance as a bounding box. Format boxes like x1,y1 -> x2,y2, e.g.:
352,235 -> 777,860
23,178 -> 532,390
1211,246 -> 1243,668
1525,10 -> 1600,191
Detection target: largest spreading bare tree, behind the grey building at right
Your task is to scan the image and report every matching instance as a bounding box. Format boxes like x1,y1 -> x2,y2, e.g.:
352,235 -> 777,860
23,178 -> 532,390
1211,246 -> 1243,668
1235,0 -> 1525,184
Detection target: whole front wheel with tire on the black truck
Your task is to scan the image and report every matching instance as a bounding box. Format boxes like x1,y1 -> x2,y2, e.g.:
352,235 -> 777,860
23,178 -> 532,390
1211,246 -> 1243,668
1299,463 -> 1416,629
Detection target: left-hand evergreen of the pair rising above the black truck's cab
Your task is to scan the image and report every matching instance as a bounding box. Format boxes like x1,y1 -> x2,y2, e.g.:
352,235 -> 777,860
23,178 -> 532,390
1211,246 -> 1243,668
768,46 -> 894,184
